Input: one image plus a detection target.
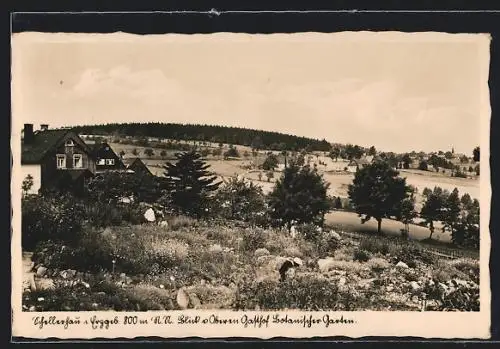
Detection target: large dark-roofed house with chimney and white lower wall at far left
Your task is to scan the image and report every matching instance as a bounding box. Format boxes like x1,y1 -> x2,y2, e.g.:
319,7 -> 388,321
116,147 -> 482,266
21,124 -> 96,193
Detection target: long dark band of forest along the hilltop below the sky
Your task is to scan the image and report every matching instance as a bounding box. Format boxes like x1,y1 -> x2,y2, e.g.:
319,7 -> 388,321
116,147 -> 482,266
69,123 -> 331,151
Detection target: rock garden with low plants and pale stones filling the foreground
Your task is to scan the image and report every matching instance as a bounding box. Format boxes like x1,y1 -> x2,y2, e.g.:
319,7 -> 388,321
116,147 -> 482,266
23,219 -> 479,311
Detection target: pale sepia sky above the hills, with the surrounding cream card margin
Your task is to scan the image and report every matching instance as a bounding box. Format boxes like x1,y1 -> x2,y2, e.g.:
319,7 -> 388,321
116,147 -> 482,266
12,32 -> 489,154
